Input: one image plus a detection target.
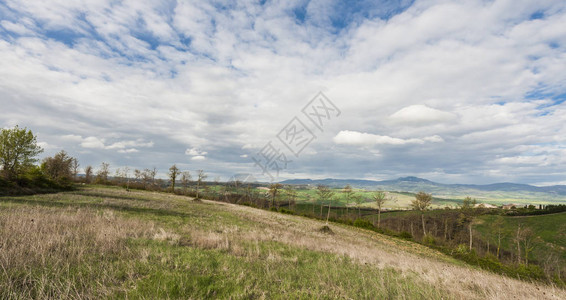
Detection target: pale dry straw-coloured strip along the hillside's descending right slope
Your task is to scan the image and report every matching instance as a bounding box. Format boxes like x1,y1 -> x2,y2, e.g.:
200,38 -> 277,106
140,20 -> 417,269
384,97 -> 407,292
202,199 -> 566,299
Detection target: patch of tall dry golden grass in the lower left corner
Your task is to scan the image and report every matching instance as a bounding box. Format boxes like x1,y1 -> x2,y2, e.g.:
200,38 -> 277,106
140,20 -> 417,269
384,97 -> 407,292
0,207 -> 155,299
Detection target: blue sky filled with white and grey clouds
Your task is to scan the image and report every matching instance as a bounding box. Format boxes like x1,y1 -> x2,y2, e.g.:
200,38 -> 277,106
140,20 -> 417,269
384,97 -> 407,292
0,0 -> 566,185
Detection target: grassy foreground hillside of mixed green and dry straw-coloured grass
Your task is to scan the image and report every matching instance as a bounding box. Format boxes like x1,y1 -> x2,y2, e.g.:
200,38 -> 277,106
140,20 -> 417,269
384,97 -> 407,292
0,187 -> 566,299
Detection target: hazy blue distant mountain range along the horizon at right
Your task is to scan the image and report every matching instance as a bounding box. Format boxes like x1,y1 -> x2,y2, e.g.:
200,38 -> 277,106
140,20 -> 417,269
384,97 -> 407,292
281,176 -> 566,199
